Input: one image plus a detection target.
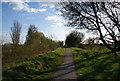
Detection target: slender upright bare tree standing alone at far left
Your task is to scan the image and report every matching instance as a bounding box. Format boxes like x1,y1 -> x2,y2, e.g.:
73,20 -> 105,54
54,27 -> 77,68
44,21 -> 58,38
10,21 -> 22,45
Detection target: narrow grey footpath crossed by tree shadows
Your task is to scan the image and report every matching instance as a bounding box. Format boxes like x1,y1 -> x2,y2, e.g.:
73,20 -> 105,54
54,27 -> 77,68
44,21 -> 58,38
52,48 -> 77,79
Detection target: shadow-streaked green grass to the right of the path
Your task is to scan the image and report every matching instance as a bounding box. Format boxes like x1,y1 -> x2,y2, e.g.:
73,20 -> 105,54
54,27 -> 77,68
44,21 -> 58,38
71,48 -> 120,81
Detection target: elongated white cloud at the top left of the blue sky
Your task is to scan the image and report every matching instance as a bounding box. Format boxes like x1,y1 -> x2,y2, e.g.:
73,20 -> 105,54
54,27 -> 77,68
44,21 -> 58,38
4,0 -> 46,13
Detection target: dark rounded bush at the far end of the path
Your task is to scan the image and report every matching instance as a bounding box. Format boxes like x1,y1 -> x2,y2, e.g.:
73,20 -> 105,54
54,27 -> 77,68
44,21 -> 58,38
65,31 -> 84,47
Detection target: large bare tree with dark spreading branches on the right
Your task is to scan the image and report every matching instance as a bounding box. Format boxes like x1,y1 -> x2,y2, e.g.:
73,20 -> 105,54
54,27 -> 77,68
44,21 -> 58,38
59,1 -> 120,56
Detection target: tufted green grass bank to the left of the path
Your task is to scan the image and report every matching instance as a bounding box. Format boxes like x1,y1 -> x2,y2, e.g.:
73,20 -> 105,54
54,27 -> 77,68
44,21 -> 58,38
3,48 -> 65,81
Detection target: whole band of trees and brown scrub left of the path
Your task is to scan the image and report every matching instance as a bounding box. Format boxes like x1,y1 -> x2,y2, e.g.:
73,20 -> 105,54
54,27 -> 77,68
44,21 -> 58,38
2,21 -> 63,65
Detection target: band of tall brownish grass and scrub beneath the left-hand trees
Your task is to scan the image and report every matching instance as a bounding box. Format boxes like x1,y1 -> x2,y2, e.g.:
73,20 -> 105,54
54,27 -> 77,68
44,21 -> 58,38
2,44 -> 58,65
